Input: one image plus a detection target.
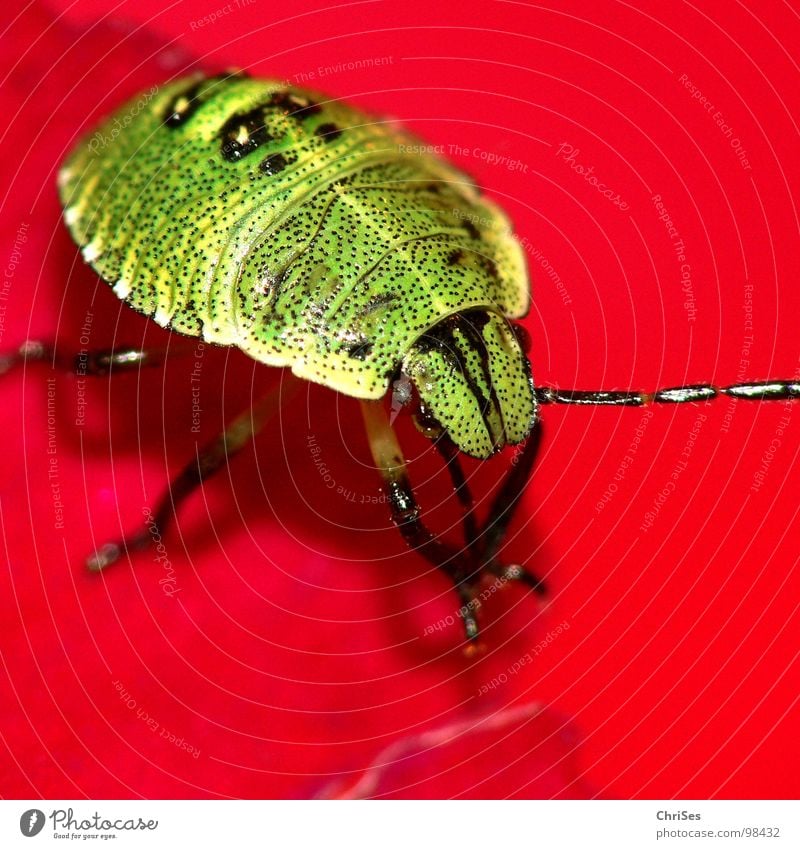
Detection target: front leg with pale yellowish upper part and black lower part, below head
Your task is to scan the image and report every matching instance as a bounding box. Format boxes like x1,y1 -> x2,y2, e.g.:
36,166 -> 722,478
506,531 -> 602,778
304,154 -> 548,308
361,401 -> 478,646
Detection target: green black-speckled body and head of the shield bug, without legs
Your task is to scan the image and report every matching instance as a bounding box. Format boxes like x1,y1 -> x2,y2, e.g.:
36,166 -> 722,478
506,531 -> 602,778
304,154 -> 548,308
60,73 -> 535,457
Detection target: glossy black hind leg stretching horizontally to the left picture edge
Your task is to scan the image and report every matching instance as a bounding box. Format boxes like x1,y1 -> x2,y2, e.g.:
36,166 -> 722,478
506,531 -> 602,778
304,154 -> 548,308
0,340 -> 189,377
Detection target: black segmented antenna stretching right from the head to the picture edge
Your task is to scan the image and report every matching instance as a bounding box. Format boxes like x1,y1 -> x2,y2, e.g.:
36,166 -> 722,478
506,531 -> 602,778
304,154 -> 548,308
534,380 -> 800,407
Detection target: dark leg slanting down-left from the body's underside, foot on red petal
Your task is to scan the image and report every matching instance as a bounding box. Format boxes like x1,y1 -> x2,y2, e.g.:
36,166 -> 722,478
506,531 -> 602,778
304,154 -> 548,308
86,392 -> 285,572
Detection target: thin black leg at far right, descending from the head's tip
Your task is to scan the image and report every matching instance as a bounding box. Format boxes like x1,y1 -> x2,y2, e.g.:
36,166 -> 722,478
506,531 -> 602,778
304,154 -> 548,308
481,422 -> 545,594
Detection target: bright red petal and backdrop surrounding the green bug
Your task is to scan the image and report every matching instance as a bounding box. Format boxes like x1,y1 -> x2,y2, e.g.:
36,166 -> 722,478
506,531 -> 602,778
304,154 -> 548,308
0,0 -> 800,798
